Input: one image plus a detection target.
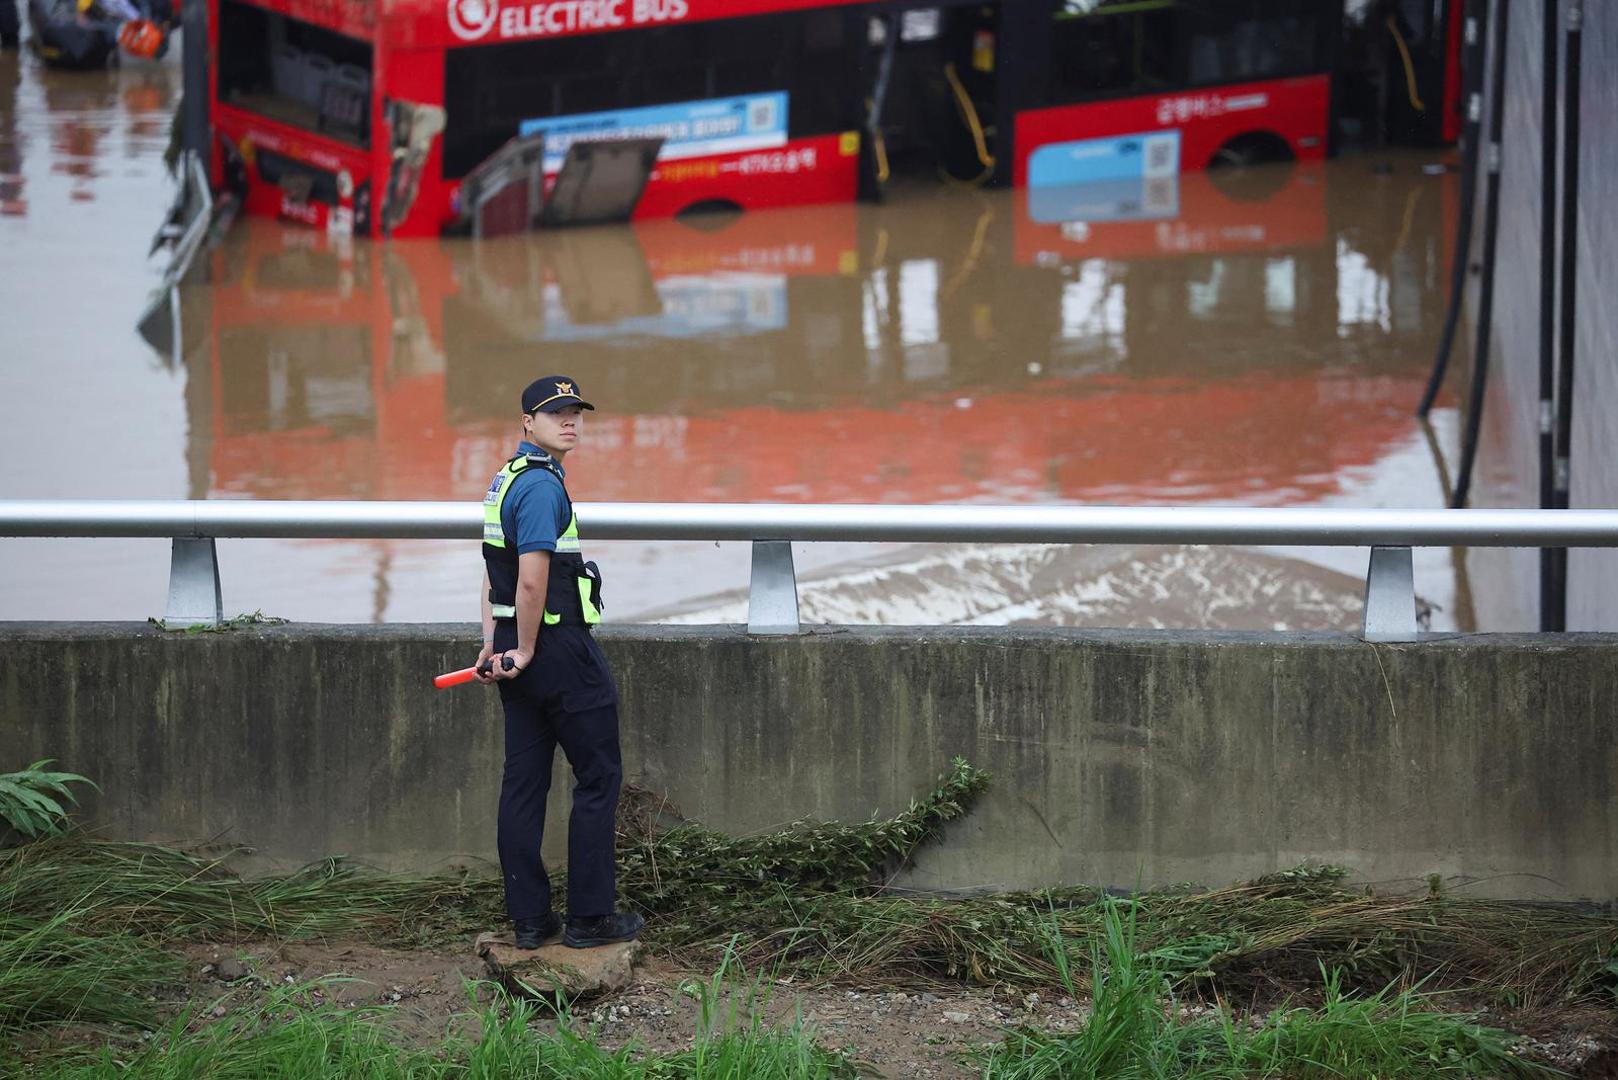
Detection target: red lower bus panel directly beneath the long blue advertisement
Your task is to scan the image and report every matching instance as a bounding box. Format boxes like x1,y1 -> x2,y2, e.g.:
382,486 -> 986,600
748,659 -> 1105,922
634,131 -> 859,220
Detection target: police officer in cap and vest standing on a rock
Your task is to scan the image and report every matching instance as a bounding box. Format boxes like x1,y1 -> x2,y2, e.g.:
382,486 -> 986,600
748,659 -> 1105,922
477,376 -> 644,949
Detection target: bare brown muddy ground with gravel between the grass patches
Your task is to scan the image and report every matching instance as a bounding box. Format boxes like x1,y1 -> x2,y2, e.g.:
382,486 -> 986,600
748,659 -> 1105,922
170,941 -> 1618,1080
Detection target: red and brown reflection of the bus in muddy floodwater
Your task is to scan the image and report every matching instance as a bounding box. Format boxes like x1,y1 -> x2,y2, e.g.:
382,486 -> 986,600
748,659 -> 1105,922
186,159 -> 1448,504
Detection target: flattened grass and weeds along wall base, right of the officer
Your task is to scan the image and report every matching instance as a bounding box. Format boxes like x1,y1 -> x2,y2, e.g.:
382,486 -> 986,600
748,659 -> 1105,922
618,759 -> 1618,1006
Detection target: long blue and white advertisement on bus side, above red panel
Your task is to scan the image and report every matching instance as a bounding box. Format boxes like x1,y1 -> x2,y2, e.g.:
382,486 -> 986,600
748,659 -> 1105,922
518,91 -> 786,173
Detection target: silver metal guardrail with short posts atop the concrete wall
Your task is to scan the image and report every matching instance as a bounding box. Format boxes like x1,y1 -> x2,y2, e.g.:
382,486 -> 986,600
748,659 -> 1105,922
0,500 -> 1618,641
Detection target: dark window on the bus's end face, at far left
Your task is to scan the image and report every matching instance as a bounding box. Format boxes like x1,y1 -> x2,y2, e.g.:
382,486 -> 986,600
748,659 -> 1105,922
218,0 -> 372,147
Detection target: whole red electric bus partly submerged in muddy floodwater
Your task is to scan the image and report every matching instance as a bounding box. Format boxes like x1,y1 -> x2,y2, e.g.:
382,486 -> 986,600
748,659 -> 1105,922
207,0 -> 1455,236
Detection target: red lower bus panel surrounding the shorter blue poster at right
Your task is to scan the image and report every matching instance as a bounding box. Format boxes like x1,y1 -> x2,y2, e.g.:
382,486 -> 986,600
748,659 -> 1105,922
1013,74 -> 1332,188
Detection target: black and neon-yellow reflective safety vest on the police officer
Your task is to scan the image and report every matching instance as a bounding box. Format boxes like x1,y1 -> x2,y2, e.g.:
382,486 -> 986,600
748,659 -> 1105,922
484,453 -> 604,627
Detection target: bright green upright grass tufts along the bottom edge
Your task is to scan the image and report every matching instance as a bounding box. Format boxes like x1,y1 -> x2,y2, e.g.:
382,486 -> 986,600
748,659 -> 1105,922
12,900 -> 1555,1080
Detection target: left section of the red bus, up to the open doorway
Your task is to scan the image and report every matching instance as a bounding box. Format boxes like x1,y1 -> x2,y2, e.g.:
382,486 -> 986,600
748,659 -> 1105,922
209,0 -> 866,236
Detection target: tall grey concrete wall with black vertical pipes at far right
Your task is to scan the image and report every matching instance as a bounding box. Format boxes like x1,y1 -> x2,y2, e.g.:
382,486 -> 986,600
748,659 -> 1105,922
1475,0 -> 1618,630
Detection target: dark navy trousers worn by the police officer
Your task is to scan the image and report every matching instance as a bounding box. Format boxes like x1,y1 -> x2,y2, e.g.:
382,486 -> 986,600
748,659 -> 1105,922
495,620 -> 623,920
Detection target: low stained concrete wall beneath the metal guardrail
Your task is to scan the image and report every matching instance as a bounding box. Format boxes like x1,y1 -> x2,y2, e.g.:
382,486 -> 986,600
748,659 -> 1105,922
0,623 -> 1618,897
